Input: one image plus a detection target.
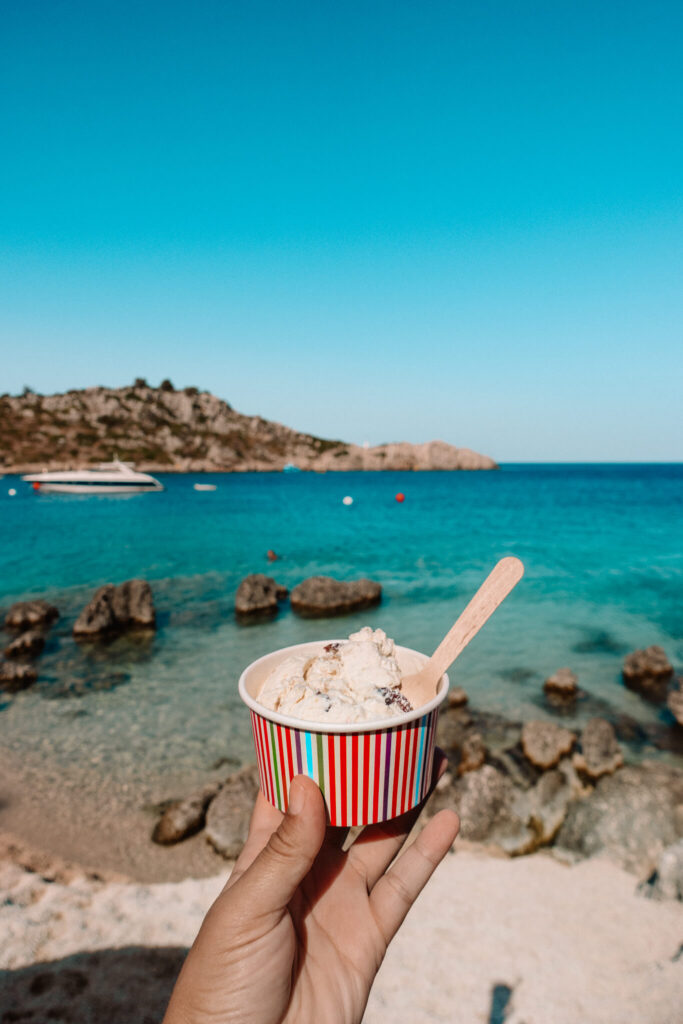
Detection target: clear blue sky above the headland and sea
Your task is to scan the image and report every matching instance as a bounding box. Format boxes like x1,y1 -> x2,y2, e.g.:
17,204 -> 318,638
0,0 -> 683,462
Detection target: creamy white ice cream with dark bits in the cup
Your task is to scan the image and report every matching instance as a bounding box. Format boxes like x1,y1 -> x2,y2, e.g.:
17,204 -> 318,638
257,626 -> 413,722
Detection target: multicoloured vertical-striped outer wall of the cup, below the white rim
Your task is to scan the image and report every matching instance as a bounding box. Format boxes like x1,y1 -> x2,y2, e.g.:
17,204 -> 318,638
251,709 -> 438,826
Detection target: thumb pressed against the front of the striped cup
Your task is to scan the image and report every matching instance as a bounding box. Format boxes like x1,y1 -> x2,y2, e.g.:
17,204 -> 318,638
236,775 -> 326,914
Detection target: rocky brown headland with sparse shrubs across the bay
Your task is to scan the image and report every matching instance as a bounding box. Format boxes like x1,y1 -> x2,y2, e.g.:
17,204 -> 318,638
0,380 -> 497,472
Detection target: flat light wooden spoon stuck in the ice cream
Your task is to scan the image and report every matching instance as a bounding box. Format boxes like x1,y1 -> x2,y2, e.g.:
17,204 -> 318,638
400,557 -> 524,708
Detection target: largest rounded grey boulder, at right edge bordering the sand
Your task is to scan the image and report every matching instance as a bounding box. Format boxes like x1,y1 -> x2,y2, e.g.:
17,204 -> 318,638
557,761 -> 683,878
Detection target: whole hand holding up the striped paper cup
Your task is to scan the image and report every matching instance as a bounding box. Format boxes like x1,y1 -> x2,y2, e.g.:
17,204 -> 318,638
164,751 -> 460,1024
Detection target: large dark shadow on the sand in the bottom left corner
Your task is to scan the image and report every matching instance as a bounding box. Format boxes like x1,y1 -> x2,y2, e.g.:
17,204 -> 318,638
0,946 -> 187,1024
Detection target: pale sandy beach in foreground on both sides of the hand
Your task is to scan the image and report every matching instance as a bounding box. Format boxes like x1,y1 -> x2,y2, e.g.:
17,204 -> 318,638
0,850 -> 683,1024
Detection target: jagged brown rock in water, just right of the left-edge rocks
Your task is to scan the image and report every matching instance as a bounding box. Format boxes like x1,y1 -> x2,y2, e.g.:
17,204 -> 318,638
74,580 -> 156,640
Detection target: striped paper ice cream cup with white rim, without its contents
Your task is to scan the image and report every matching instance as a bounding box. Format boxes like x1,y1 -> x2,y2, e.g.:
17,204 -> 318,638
239,640 -> 449,826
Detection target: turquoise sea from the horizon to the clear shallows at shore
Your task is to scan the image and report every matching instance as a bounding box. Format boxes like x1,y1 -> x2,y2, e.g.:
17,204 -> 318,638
0,465 -> 683,823
